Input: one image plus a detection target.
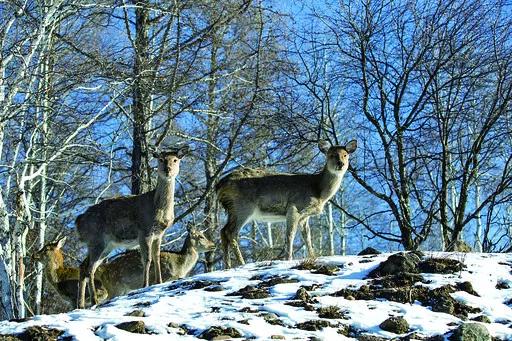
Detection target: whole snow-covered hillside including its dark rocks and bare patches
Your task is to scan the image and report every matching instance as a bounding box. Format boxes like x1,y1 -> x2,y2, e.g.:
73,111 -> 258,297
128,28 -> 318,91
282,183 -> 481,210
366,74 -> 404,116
0,253 -> 512,341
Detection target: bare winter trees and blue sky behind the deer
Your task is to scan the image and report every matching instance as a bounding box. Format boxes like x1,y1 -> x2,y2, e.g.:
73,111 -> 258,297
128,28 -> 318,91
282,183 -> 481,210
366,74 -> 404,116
0,0 -> 512,320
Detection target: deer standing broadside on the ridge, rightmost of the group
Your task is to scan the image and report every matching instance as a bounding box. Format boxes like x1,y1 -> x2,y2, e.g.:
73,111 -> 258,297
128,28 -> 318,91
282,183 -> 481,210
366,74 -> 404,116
215,140 -> 357,268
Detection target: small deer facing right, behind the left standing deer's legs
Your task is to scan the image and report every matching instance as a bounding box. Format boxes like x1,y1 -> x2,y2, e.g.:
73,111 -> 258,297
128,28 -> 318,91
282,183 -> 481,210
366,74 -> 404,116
97,228 -> 215,299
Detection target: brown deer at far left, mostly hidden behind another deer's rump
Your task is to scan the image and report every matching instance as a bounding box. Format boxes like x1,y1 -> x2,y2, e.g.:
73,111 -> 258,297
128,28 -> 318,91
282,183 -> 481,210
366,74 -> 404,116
32,237 -> 108,307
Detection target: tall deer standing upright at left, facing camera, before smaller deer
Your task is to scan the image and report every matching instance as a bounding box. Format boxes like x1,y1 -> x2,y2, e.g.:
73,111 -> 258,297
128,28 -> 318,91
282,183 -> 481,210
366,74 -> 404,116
76,146 -> 189,308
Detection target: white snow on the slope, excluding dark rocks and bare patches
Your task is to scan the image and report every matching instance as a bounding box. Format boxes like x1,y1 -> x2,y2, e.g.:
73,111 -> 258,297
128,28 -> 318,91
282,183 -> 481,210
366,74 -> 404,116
0,253 -> 512,341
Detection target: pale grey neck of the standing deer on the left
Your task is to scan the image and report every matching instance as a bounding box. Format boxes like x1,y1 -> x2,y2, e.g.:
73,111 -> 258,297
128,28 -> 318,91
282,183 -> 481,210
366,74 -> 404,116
153,176 -> 176,227
